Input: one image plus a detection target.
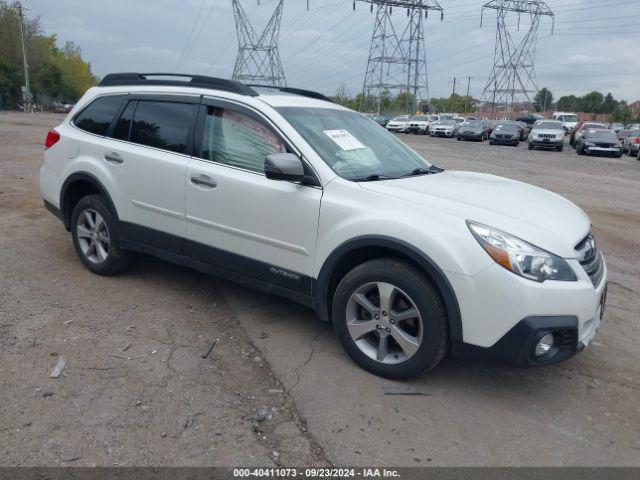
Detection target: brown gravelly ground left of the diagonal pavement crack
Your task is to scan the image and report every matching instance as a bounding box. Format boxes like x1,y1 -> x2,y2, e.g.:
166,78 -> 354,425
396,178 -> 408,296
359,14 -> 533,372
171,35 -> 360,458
0,114 -> 327,466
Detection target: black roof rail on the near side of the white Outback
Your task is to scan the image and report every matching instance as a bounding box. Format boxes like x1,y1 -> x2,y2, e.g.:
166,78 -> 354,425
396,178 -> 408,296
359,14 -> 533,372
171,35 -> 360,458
100,72 -> 258,97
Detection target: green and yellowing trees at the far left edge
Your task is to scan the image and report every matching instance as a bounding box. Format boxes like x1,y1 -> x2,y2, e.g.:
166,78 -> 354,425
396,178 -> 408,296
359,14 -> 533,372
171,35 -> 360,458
0,0 -> 97,109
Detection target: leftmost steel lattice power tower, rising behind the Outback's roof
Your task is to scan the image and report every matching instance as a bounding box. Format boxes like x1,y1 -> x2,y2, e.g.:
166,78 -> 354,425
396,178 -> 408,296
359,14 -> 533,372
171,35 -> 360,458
231,0 -> 287,87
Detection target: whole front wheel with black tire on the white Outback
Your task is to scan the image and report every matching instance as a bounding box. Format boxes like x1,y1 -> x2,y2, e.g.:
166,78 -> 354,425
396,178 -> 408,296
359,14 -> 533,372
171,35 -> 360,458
332,258 -> 449,379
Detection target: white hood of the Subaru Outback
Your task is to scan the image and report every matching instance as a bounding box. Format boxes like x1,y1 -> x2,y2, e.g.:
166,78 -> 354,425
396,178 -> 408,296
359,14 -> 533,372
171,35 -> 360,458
361,171 -> 591,258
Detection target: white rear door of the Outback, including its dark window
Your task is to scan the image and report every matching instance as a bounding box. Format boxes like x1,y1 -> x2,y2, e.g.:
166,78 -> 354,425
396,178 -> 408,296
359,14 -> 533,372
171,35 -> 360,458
98,96 -> 199,251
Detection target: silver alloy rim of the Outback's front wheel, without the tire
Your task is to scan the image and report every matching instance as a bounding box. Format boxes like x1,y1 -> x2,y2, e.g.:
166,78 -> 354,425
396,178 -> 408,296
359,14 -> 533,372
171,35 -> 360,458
346,282 -> 424,364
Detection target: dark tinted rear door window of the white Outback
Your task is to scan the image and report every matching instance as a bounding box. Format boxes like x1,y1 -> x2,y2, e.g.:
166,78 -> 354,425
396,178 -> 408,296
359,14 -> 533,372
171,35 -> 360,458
130,100 -> 195,153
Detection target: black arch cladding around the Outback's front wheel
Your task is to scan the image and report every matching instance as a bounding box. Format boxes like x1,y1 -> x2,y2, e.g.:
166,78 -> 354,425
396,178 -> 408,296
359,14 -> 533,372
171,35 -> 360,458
314,236 -> 462,342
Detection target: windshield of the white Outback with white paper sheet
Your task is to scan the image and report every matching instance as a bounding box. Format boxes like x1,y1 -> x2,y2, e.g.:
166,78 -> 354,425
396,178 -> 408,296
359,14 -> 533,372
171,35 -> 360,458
277,107 -> 431,181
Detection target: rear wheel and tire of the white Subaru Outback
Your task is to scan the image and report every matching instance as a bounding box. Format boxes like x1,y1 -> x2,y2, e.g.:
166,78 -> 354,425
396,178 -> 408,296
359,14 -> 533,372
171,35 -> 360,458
71,195 -> 131,275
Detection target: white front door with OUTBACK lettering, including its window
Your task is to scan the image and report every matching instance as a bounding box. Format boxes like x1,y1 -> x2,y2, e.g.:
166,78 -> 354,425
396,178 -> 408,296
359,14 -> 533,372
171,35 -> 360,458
185,99 -> 322,293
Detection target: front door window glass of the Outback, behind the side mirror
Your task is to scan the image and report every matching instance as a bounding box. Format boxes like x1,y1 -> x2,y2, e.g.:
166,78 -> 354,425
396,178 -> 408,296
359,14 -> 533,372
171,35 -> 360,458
201,106 -> 287,173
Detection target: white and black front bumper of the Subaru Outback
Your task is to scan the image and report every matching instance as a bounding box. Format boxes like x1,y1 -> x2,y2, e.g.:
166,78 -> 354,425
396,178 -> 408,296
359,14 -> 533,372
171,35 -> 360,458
448,260 -> 607,367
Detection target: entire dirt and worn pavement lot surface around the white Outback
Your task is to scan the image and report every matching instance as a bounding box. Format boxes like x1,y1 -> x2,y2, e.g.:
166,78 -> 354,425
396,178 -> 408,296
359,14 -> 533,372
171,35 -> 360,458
0,114 -> 640,466
